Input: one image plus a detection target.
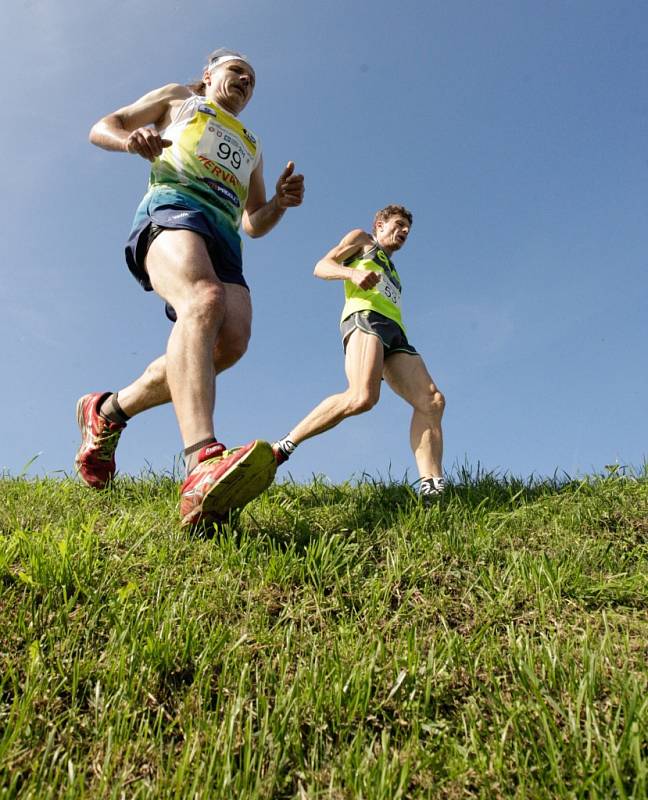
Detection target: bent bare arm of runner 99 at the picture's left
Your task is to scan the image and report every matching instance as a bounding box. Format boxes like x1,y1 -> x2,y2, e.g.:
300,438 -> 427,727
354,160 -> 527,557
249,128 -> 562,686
90,83 -> 191,161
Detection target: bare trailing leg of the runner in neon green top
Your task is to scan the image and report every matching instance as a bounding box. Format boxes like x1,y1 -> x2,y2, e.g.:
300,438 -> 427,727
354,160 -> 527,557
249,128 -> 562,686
288,330 -> 383,445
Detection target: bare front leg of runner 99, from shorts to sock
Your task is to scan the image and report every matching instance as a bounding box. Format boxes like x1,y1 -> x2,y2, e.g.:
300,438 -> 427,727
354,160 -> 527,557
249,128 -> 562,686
137,230 -> 225,447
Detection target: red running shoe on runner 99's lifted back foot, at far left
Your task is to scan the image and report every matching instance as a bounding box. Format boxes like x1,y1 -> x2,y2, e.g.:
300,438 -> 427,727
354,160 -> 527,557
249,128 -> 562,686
74,392 -> 126,489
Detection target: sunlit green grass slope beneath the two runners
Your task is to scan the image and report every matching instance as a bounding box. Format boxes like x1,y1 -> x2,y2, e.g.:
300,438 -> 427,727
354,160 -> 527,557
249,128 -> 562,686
0,473 -> 648,800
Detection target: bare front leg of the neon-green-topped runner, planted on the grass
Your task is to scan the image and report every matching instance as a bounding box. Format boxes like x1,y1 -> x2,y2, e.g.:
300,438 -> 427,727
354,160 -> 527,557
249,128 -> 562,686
384,353 -> 445,478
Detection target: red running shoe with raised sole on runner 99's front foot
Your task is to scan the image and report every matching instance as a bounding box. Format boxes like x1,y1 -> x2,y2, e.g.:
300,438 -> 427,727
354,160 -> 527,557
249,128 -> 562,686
180,439 -> 277,527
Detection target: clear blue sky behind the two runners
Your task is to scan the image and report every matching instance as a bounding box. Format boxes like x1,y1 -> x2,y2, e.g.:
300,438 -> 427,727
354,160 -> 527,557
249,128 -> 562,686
0,0 -> 648,482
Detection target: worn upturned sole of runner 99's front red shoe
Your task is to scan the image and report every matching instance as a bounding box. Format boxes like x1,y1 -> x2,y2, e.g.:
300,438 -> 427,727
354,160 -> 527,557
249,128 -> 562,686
182,439 -> 277,527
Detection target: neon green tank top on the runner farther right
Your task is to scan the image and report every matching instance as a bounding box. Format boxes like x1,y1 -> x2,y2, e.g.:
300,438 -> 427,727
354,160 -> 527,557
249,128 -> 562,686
341,239 -> 405,333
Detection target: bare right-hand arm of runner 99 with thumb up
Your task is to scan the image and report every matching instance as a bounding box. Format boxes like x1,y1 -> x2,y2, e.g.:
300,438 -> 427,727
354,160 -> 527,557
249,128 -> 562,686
241,158 -> 304,239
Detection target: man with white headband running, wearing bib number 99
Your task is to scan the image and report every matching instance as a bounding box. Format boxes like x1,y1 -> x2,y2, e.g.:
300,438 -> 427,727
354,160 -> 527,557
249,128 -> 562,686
75,49 -> 304,525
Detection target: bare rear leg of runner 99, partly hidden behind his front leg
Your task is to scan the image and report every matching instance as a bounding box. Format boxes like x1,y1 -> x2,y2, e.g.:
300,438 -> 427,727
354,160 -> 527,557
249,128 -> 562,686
119,283 -> 252,417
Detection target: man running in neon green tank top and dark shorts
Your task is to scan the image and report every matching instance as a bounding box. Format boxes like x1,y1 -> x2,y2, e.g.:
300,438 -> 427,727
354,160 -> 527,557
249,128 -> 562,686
273,205 -> 445,504
